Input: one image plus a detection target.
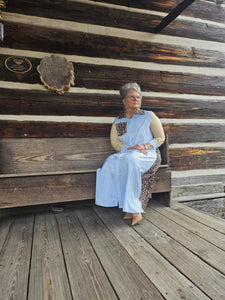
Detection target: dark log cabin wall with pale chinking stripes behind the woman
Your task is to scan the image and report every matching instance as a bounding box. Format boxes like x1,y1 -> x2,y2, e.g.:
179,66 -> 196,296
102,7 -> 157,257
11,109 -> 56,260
0,0 -> 225,204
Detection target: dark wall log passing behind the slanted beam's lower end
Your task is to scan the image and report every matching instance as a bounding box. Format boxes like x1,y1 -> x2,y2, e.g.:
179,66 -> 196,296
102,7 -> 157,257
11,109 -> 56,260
6,1 -> 224,42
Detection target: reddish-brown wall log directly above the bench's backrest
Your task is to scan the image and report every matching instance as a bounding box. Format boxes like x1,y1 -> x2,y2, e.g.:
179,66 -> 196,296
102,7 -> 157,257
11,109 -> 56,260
0,120 -> 225,144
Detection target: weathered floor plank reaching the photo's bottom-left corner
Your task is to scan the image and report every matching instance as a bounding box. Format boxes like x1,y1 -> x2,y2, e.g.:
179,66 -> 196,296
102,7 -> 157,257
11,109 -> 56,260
0,215 -> 33,300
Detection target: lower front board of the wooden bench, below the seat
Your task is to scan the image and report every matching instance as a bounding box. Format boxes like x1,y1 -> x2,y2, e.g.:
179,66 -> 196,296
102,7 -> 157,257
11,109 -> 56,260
0,168 -> 170,208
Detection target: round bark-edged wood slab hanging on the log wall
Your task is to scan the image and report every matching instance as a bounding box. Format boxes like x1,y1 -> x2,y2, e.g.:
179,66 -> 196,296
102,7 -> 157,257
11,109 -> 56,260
37,54 -> 75,94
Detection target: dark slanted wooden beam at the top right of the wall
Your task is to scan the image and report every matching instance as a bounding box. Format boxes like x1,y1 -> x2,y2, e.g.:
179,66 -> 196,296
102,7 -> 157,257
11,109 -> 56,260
153,0 -> 195,33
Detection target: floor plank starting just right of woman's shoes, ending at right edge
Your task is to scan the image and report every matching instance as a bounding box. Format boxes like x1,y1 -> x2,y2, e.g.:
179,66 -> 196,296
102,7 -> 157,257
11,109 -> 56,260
147,203 -> 225,274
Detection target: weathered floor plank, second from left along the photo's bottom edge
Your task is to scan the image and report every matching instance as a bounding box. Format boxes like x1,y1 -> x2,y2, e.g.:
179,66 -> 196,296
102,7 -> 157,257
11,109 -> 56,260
27,213 -> 72,300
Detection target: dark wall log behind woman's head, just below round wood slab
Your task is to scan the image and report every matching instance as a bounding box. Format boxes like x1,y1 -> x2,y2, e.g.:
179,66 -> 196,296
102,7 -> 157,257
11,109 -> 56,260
0,85 -> 225,119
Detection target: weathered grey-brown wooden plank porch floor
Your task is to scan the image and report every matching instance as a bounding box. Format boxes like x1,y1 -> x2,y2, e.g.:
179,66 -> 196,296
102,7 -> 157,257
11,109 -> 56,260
0,202 -> 225,300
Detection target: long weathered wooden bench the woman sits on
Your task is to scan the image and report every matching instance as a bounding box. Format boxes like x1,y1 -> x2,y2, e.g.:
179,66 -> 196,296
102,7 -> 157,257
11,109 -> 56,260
0,138 -> 171,208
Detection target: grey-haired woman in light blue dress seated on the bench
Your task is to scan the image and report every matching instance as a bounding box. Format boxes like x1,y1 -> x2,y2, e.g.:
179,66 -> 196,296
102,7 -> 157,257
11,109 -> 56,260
95,83 -> 165,225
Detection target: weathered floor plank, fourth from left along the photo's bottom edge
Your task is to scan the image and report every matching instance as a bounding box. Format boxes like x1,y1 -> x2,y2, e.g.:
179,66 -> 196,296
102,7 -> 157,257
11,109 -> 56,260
77,209 -> 163,299
